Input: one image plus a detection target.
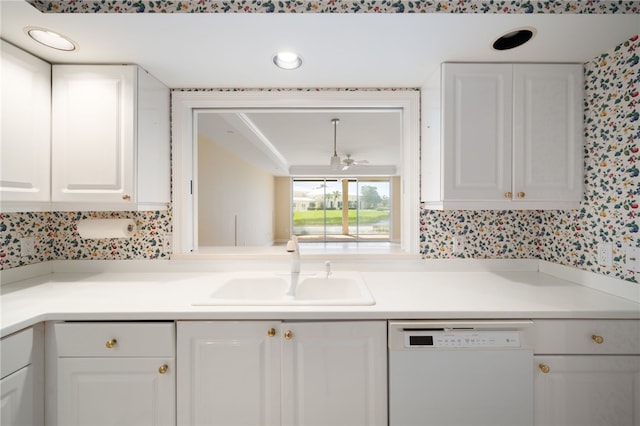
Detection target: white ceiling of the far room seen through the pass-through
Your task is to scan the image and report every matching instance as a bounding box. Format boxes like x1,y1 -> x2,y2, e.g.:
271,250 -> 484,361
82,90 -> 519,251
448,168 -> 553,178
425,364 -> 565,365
198,109 -> 402,175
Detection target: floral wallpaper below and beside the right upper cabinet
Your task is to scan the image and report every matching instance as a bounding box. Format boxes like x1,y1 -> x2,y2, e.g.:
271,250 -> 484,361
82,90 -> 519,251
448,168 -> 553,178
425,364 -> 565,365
420,35 -> 640,282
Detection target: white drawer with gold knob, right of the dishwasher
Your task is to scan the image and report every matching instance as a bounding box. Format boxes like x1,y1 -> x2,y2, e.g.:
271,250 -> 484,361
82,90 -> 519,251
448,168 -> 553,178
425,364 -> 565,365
533,320 -> 640,355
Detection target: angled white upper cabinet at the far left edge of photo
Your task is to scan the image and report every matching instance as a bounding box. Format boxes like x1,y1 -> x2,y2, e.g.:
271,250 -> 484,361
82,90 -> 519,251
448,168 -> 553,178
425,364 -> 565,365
0,40 -> 51,210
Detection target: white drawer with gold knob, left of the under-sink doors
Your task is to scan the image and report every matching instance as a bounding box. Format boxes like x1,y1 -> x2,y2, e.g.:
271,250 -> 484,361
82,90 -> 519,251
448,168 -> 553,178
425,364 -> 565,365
55,322 -> 175,357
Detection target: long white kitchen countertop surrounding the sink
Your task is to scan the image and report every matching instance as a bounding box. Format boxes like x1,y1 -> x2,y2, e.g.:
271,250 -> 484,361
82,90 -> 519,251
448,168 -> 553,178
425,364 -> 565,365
0,260 -> 640,336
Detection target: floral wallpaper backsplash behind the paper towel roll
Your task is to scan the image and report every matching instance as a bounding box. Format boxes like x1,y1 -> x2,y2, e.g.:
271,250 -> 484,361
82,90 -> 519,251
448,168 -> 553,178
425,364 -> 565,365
0,211 -> 172,269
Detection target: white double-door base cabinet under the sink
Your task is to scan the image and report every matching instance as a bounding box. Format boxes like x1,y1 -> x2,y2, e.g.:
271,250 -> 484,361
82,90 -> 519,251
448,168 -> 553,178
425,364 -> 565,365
177,321 -> 387,426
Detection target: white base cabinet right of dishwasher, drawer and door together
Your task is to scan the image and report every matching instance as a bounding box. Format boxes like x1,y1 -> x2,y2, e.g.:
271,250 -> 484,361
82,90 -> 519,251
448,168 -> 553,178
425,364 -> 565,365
534,320 -> 640,426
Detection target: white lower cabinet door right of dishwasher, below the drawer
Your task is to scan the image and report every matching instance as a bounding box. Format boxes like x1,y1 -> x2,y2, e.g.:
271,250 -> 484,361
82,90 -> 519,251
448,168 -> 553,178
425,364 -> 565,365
534,355 -> 640,426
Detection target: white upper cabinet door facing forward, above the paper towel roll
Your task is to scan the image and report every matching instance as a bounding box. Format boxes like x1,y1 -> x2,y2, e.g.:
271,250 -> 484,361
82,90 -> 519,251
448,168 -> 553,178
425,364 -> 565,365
52,65 -> 137,202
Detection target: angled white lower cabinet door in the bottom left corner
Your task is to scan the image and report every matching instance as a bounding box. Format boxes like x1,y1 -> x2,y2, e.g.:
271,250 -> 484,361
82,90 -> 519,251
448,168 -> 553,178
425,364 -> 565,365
0,366 -> 36,426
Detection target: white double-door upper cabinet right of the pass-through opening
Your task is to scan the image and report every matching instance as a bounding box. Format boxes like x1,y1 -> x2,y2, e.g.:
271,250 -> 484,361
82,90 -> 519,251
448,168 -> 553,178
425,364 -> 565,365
422,63 -> 583,210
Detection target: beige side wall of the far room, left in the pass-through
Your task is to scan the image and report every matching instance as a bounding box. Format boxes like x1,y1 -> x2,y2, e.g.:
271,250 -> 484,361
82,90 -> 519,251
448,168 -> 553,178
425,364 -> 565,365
198,136 -> 275,246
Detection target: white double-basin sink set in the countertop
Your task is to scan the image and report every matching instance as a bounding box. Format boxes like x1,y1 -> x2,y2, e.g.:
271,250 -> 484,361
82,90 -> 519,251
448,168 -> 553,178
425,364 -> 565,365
193,271 -> 375,306
